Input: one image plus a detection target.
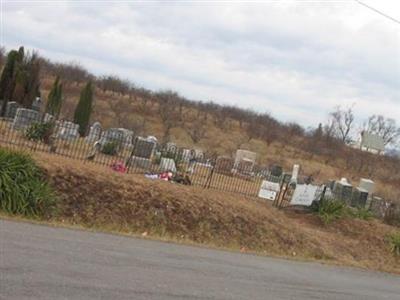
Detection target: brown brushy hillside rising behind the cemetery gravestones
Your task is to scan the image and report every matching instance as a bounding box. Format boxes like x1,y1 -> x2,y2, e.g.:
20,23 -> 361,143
36,72 -> 400,201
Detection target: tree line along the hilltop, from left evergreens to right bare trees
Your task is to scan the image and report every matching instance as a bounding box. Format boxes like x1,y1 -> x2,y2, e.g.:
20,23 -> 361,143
0,47 -> 400,154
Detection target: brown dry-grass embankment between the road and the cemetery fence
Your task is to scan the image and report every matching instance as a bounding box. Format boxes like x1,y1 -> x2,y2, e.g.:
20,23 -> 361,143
35,154 -> 400,273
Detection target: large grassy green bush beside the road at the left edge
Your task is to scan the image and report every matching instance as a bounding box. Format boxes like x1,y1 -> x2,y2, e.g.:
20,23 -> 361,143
0,148 -> 55,217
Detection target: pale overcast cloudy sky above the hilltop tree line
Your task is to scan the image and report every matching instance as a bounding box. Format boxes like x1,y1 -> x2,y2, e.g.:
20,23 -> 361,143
1,0 -> 400,126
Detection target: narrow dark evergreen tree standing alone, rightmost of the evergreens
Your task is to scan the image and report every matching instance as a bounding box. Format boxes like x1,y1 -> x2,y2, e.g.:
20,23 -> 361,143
74,81 -> 93,136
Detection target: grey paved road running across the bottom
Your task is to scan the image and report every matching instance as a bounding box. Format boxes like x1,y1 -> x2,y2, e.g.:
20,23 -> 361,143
0,220 -> 400,300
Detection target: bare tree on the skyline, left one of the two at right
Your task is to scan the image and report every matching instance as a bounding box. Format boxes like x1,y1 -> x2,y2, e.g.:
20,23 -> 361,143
329,106 -> 354,143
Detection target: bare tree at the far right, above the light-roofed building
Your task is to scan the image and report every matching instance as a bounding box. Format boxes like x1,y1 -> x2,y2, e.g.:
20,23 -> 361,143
364,115 -> 400,146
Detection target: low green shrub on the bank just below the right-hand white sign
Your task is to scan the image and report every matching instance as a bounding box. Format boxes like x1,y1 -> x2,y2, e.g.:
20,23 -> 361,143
314,198 -> 348,224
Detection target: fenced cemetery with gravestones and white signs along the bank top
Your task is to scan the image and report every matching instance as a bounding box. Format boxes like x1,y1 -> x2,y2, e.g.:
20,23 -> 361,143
2,102 -> 396,223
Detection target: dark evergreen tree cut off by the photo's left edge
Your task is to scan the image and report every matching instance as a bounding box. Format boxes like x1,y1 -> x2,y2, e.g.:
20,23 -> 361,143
0,50 -> 19,116
